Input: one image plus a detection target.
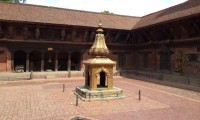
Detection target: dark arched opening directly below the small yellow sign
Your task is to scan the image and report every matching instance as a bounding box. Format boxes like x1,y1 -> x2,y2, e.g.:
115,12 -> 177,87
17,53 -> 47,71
44,51 -> 55,71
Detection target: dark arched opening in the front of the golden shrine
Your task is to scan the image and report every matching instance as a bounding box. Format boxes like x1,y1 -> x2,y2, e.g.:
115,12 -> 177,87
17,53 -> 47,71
97,71 -> 107,88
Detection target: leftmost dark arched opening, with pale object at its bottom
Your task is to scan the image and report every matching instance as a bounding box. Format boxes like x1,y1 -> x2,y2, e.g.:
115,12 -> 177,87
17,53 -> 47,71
14,50 -> 26,72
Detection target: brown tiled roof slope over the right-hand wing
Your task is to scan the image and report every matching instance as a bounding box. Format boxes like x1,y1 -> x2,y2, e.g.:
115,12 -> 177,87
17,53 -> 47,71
133,0 -> 200,29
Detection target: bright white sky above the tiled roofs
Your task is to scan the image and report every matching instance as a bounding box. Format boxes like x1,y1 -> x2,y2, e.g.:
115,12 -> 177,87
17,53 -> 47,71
26,0 -> 187,17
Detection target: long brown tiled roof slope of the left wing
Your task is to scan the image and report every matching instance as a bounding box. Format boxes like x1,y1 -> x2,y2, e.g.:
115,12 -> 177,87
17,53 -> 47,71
0,2 -> 140,30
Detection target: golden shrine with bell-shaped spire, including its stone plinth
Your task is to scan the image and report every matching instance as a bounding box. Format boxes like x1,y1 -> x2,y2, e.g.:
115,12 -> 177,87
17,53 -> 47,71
75,23 -> 124,101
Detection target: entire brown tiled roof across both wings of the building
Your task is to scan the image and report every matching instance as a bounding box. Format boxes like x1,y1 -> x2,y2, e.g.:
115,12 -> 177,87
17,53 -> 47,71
0,0 -> 200,30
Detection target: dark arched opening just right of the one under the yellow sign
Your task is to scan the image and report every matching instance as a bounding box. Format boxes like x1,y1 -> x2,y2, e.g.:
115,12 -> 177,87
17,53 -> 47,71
58,51 -> 68,71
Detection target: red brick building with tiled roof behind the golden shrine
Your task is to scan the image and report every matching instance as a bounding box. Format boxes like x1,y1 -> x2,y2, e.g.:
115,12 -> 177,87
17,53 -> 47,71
0,0 -> 200,82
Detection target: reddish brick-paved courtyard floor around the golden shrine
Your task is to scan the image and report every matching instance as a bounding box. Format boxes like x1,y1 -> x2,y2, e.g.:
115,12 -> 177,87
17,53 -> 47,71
0,77 -> 200,120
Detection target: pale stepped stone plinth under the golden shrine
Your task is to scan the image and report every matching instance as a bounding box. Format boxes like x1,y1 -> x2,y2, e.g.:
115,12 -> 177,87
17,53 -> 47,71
75,86 -> 124,101
